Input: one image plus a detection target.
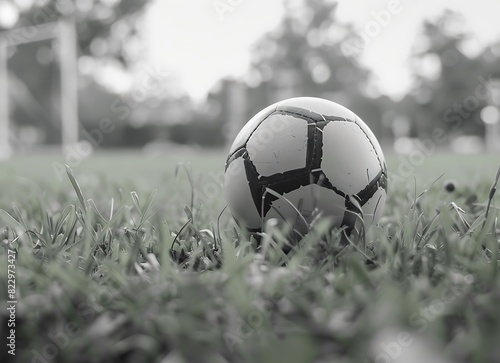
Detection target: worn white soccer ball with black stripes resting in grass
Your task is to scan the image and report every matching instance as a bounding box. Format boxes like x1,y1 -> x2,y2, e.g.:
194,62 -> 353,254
224,97 -> 387,236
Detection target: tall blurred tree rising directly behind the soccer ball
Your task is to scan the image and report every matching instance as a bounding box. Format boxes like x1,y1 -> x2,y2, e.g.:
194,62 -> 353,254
213,0 -> 387,142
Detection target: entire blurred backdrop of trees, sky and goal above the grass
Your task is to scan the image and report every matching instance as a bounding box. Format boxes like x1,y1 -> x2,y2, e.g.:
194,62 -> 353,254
0,0 -> 500,158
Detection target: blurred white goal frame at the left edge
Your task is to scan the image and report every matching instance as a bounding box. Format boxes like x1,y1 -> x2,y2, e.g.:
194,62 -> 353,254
0,19 -> 79,160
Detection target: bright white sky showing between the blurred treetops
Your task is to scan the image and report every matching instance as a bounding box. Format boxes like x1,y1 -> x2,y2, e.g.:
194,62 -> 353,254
143,0 -> 500,99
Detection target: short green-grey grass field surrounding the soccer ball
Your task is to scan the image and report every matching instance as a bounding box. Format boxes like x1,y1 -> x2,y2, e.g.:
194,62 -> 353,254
0,153 -> 500,363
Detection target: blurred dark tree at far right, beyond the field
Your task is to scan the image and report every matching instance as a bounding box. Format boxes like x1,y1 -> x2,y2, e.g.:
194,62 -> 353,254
402,11 -> 500,136
